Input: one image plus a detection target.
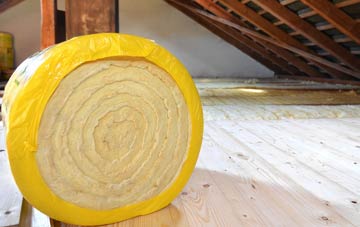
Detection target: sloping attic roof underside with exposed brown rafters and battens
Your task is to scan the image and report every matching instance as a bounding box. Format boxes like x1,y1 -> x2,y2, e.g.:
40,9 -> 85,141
165,0 -> 360,81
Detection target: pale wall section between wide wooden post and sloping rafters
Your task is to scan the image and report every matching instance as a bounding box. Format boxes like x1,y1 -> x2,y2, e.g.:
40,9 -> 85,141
119,0 -> 273,77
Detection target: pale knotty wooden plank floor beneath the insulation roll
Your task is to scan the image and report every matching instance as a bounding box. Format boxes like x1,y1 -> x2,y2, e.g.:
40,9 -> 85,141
0,79 -> 360,227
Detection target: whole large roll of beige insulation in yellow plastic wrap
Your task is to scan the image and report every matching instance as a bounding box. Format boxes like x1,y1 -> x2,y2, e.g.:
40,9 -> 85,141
2,33 -> 203,225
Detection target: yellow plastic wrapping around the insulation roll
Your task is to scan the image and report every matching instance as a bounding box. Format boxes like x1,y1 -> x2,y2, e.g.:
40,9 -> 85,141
2,33 -> 203,225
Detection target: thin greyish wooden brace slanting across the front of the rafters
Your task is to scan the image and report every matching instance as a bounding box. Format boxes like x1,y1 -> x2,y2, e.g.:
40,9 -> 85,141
173,0 -> 360,78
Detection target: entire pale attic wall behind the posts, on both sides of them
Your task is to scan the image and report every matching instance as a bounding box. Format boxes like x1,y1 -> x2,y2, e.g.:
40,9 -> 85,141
0,0 -> 273,77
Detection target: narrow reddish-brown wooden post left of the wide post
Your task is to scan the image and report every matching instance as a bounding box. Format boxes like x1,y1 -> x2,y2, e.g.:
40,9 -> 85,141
40,0 -> 57,49
